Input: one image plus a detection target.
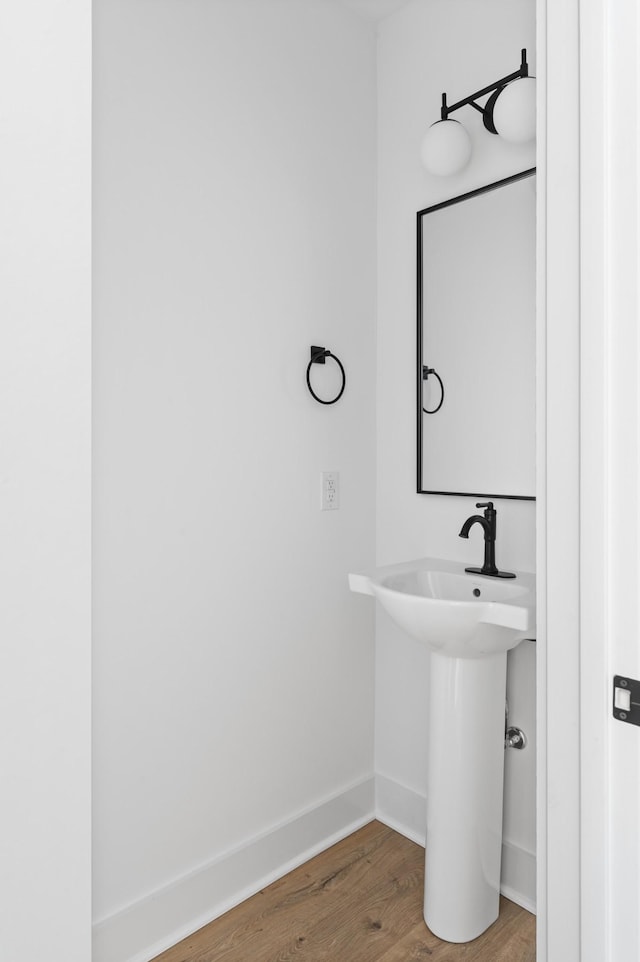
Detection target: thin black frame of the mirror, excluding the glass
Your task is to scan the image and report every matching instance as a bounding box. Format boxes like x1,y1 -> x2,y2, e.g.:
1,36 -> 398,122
416,167 -> 536,501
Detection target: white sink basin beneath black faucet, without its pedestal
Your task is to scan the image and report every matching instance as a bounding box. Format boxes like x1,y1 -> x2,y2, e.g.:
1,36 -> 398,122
349,558 -> 535,658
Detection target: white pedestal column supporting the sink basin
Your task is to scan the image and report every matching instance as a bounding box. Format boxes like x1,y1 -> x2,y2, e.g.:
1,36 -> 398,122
424,651 -> 507,942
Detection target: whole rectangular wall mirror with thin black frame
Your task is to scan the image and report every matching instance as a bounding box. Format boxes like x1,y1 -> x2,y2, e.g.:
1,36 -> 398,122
417,168 -> 536,501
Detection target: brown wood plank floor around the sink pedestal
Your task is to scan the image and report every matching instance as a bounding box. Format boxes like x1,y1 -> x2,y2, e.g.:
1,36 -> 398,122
154,822 -> 536,962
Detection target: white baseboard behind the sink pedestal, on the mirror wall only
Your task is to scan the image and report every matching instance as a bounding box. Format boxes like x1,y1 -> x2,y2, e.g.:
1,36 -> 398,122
376,774 -> 536,915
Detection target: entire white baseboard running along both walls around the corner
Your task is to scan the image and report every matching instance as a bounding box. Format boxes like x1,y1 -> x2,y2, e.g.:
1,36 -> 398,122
92,775 -> 536,962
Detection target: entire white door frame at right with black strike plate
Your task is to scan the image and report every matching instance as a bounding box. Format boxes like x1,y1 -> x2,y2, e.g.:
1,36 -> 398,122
537,0 -> 640,962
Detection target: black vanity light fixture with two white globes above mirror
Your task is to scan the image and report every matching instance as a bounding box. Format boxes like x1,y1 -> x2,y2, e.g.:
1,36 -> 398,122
420,49 -> 536,177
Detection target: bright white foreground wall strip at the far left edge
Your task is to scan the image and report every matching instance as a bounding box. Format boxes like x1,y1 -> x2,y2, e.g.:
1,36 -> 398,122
0,0 -> 91,962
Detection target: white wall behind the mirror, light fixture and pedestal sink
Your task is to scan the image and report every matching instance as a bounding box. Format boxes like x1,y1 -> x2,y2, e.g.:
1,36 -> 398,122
376,0 -> 535,892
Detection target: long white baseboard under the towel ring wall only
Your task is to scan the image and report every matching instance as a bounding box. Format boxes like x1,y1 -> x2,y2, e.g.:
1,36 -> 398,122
92,776 -> 375,962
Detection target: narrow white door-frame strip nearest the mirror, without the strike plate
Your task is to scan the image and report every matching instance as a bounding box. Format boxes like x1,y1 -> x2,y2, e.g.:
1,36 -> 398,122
536,0 -> 580,962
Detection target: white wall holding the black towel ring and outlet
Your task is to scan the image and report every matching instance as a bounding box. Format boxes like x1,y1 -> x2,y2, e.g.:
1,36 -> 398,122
94,0 -> 376,952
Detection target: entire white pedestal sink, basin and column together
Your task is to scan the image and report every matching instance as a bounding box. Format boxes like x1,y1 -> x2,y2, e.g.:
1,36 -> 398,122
349,558 -> 535,942
